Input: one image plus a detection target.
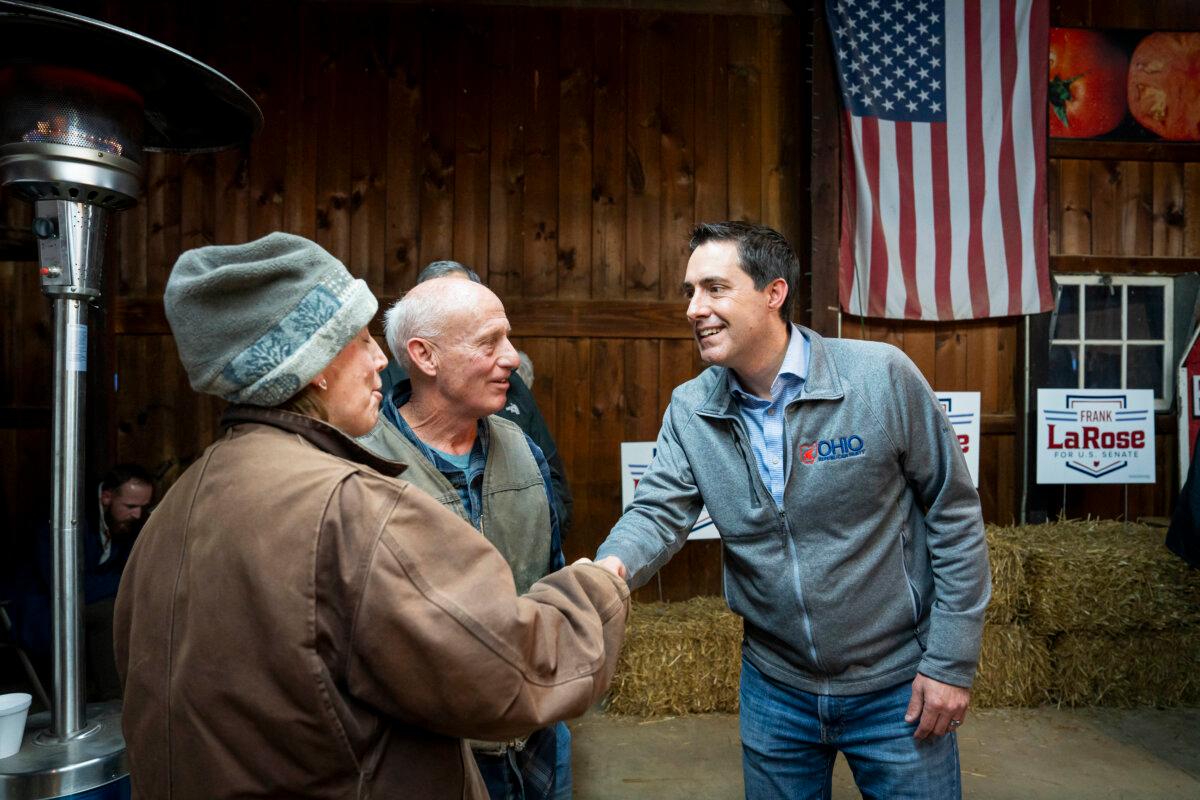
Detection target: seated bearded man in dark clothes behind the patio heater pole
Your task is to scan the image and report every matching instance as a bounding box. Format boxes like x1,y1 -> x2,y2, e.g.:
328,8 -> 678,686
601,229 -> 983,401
25,464 -> 154,702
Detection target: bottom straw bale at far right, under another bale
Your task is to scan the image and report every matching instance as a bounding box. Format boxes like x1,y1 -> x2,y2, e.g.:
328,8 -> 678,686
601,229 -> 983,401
1050,628 -> 1200,708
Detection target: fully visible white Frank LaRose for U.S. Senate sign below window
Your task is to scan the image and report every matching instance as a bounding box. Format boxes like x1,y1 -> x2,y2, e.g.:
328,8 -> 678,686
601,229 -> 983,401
1037,389 -> 1154,483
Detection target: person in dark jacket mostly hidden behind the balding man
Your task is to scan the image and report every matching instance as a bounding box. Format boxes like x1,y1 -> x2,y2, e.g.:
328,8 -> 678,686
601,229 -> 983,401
366,261 -> 571,539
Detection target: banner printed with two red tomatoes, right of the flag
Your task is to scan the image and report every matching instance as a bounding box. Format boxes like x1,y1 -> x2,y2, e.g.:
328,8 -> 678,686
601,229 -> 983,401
1048,28 -> 1200,142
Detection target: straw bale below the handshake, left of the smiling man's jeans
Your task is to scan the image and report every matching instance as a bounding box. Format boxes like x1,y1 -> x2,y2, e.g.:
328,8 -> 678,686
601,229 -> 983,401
607,597 -> 742,716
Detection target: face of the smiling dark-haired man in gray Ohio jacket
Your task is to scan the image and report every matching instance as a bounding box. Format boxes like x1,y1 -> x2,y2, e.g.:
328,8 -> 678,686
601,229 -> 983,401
683,241 -> 779,374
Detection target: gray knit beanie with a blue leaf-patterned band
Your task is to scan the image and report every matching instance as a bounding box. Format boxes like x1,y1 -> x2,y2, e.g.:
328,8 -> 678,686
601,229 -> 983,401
163,233 -> 379,407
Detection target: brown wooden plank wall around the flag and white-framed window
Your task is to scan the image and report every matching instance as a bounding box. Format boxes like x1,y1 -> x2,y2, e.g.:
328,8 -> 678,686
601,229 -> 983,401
811,0 -> 1200,523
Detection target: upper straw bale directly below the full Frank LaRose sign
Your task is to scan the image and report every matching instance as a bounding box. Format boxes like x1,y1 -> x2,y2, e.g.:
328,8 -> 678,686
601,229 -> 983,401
1013,519 -> 1200,634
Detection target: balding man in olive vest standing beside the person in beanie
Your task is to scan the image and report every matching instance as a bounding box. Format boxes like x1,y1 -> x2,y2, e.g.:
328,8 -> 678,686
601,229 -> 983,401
367,277 -> 570,800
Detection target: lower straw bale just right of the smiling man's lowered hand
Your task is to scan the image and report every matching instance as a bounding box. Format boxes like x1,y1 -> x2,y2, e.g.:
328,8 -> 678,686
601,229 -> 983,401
971,624 -> 1050,709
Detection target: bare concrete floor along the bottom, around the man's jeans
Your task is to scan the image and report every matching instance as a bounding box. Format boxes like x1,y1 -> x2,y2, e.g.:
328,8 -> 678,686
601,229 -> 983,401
571,708 -> 1200,800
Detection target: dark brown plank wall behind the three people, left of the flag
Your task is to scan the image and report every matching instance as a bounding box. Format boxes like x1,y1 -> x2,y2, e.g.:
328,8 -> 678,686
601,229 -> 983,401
0,0 -> 808,597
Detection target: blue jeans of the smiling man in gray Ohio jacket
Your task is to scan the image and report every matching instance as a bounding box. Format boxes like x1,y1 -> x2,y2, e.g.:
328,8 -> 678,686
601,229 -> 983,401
740,658 -> 962,800
